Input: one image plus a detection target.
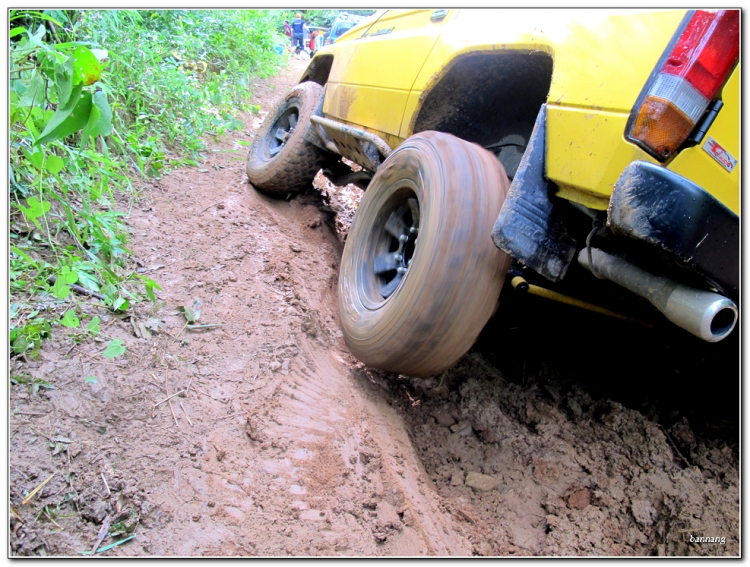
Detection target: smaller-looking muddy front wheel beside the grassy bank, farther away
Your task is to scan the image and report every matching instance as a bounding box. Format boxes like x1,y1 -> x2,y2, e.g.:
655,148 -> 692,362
246,82 -> 325,197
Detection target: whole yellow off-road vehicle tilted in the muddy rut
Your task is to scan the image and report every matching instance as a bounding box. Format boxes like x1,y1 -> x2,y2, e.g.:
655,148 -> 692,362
247,9 -> 740,376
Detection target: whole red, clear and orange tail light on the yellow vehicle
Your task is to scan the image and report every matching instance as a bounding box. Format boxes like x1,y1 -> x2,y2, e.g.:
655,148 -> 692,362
626,10 -> 740,161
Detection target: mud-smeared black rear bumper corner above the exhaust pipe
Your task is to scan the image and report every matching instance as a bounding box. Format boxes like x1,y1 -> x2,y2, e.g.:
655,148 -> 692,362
608,161 -> 740,302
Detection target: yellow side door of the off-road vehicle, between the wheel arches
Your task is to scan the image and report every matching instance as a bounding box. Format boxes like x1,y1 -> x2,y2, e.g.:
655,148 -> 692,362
323,9 -> 452,142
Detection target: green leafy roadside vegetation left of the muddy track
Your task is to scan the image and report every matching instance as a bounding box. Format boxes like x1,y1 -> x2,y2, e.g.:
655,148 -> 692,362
9,10 -> 287,359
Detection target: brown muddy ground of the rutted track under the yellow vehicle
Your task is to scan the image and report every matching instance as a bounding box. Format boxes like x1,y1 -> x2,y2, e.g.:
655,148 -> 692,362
9,61 -> 740,557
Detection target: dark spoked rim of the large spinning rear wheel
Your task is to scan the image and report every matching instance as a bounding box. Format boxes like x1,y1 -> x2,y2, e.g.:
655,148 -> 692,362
371,188 -> 420,299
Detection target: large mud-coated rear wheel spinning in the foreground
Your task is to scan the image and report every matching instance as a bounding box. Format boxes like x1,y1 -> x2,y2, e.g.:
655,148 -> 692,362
339,132 -> 510,376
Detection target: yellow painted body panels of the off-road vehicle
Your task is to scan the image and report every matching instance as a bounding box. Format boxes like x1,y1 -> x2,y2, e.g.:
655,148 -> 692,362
306,9 -> 740,214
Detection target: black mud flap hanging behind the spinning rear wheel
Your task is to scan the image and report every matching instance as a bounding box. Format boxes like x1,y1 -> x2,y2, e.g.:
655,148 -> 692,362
492,104 -> 576,282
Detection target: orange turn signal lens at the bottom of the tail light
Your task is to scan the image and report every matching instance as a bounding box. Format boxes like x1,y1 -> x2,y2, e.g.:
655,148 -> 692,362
630,96 -> 695,158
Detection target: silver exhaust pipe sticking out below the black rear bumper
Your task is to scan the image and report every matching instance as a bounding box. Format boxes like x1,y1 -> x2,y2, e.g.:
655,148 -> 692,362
578,248 -> 738,343
